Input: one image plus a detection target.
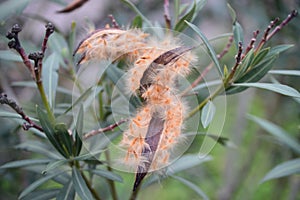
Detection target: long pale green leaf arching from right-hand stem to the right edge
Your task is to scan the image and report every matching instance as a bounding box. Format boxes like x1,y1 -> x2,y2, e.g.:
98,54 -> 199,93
232,83 -> 300,98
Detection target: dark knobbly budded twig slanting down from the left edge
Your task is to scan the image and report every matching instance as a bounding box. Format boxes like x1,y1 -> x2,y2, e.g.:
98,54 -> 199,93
0,93 -> 43,132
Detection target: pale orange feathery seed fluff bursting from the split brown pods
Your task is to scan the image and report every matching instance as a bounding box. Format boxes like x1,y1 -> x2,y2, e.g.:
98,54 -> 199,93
77,29 -> 196,171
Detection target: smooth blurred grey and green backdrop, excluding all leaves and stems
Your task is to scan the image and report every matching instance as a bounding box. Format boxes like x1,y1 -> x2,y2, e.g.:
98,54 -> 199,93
0,0 -> 300,200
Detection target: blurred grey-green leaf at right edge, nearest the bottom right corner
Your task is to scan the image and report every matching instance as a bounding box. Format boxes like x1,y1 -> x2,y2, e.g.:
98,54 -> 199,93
260,158 -> 300,183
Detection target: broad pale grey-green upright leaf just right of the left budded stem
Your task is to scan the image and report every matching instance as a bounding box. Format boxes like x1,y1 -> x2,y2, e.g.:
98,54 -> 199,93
42,53 -> 59,108
